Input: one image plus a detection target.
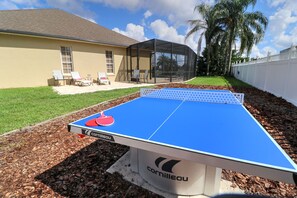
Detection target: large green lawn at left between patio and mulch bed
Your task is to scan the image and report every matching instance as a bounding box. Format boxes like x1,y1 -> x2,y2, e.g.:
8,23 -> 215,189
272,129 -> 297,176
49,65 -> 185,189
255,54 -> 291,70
0,87 -> 139,134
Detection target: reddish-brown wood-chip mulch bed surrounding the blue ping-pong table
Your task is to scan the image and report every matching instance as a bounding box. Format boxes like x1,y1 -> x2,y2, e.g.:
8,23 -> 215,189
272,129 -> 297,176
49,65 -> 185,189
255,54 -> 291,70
0,84 -> 297,197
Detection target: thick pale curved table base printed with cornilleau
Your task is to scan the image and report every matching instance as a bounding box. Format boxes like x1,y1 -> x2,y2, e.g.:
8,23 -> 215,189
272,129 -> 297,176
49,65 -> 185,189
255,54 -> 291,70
136,149 -> 221,196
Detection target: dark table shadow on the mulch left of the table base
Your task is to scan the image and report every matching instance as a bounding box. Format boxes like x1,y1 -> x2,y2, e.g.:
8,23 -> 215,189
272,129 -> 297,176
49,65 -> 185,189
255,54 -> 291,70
35,140 -> 159,197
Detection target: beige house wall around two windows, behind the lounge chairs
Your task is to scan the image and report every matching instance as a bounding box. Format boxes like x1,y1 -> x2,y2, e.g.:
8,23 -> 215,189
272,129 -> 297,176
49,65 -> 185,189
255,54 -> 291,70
0,34 -> 127,88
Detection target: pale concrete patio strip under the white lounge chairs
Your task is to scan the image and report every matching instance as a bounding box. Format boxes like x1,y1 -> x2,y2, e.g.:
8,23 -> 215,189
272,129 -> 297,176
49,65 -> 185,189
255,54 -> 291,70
53,82 -> 155,95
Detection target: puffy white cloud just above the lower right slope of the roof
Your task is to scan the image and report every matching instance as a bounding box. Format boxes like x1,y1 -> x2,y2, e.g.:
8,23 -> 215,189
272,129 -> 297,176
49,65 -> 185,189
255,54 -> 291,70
112,23 -> 148,41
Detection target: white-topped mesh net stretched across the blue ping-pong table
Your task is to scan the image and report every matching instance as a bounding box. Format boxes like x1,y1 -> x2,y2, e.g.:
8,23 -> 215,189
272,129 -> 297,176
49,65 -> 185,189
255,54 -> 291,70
140,88 -> 244,104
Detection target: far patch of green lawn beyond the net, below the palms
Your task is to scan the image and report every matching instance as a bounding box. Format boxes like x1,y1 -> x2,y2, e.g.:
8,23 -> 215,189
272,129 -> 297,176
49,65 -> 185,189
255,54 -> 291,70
187,76 -> 250,87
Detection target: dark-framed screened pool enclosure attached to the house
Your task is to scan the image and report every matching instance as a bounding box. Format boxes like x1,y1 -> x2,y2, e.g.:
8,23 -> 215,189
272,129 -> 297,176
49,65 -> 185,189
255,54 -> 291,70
122,39 -> 196,83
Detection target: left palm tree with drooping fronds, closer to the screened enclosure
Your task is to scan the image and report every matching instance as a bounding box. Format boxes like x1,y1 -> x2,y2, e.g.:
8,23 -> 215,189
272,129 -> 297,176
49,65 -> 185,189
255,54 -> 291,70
185,4 -> 222,75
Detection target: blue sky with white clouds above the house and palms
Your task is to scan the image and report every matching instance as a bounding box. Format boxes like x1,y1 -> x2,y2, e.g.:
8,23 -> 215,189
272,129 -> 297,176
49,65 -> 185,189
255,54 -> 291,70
0,0 -> 297,57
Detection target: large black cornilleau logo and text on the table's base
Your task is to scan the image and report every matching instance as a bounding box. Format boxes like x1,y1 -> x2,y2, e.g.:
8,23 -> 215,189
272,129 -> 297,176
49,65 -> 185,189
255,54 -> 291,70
147,157 -> 189,182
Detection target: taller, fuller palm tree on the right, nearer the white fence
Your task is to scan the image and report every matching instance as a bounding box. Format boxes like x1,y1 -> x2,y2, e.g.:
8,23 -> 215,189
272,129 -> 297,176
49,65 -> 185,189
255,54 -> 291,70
214,0 -> 268,74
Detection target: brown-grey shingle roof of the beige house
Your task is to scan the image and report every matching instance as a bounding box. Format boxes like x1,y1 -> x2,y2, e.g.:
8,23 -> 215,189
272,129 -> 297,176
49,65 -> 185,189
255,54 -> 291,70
0,9 -> 138,46
